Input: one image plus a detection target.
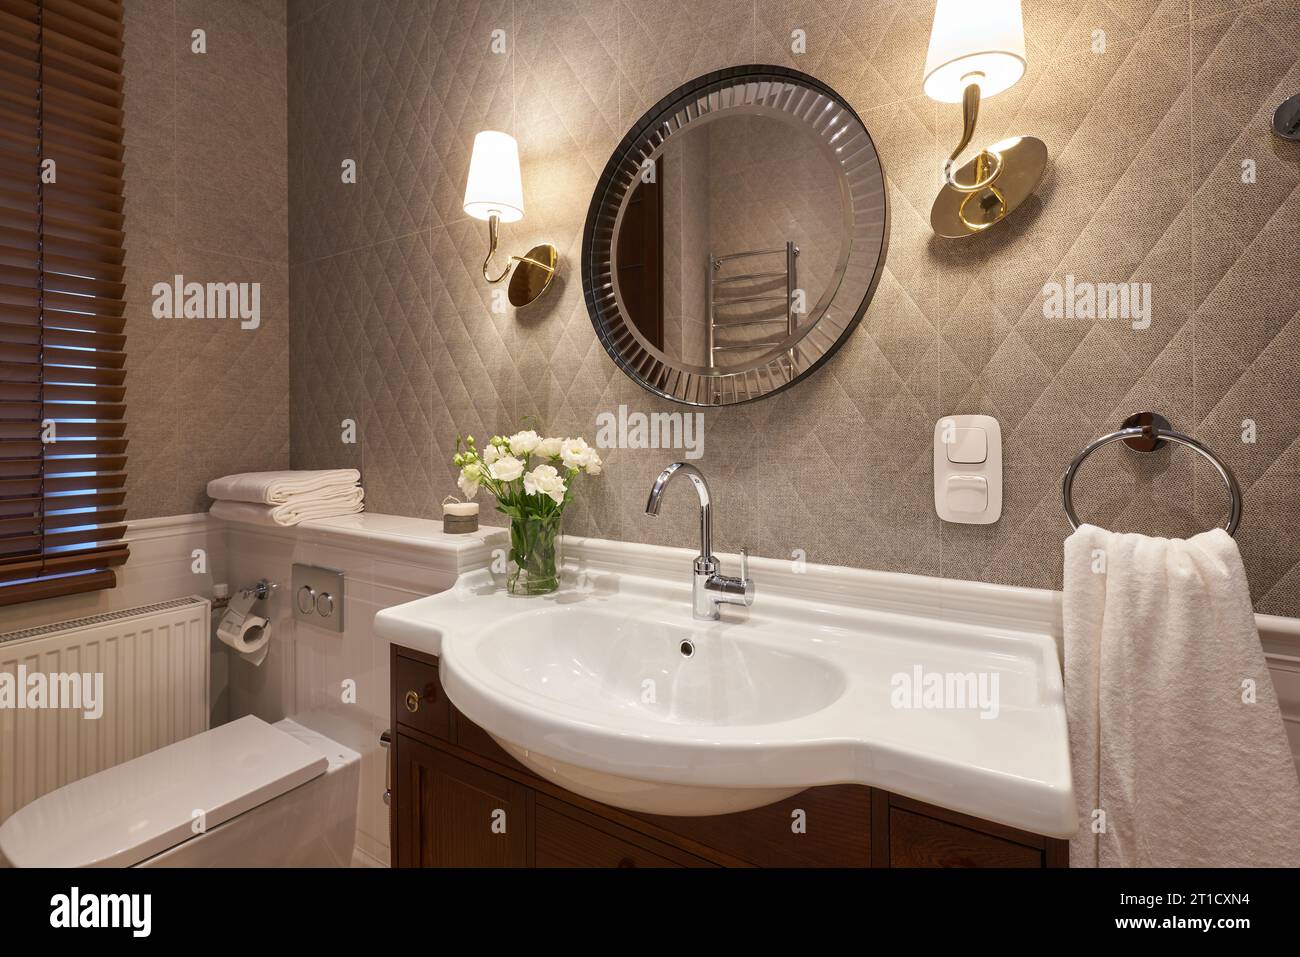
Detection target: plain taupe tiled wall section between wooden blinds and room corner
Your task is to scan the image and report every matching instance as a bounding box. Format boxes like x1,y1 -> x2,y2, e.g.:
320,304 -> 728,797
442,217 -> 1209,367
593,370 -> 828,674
125,0 -> 289,519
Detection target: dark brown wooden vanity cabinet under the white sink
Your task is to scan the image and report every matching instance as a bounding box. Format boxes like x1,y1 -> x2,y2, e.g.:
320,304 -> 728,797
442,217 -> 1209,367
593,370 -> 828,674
389,645 -> 1067,867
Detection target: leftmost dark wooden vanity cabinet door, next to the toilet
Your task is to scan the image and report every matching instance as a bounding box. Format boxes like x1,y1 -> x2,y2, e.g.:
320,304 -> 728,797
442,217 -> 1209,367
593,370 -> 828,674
394,735 -> 533,867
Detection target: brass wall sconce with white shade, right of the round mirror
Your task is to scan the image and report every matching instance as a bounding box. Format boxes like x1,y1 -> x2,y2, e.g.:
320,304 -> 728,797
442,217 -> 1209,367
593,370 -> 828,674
924,0 -> 1048,239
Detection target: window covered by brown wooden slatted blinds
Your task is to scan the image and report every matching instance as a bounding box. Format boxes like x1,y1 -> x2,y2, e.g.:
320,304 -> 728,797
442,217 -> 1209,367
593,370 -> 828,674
0,0 -> 127,605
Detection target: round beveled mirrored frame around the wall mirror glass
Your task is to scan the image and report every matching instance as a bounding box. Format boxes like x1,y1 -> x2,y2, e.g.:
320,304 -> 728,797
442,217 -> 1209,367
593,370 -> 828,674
582,65 -> 889,407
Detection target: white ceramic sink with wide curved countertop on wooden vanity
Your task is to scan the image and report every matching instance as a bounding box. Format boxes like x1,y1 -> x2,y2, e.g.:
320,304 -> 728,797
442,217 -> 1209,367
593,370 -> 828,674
376,546 -> 1075,836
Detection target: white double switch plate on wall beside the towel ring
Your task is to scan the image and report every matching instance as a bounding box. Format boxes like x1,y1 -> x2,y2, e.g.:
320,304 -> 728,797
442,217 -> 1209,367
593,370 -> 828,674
935,415 -> 1002,525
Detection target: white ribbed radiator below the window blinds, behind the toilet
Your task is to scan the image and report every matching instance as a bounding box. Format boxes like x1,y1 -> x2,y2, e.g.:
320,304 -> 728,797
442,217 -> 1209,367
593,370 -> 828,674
0,597 -> 211,820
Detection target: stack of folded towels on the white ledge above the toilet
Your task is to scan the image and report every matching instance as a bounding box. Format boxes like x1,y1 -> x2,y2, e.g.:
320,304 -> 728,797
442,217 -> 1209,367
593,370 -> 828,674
208,468 -> 365,525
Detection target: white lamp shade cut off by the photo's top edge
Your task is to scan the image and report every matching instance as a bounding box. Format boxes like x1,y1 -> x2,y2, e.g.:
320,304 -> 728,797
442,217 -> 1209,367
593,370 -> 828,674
924,0 -> 1026,103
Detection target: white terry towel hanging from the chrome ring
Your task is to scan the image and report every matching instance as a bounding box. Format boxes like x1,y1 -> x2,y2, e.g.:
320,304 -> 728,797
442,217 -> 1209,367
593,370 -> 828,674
1063,525 -> 1300,867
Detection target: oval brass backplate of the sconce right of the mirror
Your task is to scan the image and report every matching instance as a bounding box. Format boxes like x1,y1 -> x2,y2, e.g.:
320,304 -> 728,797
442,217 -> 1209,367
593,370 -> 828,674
930,137 -> 1048,239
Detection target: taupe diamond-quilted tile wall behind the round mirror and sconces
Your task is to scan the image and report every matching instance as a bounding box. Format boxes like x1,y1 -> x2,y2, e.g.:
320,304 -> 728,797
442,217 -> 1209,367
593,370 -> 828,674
287,0 -> 1300,615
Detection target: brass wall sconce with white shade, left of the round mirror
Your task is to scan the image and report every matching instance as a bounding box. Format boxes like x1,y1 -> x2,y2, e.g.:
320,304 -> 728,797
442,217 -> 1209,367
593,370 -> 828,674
464,130 -> 560,308
